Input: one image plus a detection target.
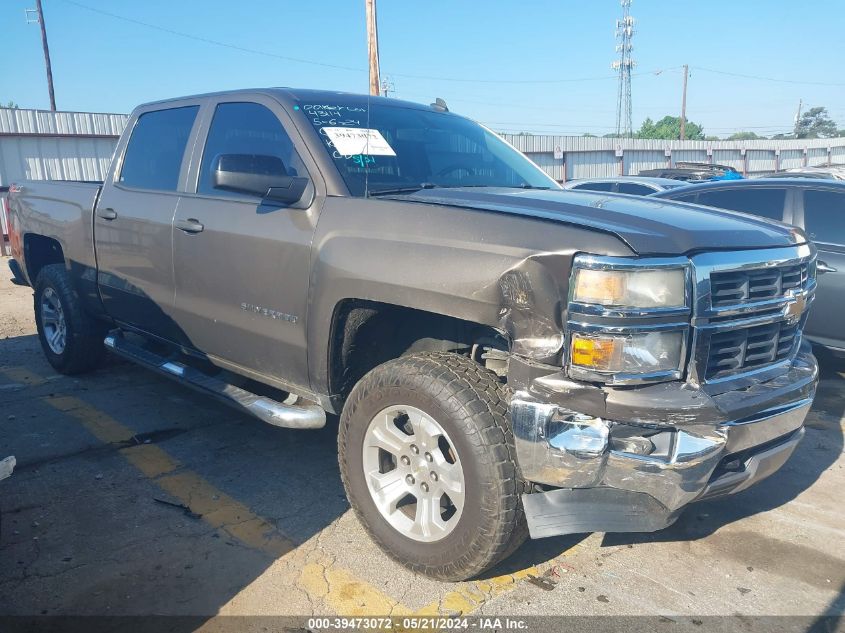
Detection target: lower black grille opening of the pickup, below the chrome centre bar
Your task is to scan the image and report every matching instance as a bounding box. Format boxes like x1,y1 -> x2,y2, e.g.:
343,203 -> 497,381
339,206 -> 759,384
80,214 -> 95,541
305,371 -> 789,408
705,321 -> 799,380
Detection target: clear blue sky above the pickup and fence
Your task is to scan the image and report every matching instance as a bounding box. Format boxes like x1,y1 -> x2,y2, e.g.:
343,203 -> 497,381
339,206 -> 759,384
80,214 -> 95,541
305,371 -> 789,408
0,0 -> 845,136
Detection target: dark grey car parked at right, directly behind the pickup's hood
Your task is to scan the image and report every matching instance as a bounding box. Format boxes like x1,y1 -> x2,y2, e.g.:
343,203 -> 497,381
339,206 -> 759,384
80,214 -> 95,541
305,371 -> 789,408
655,178 -> 845,355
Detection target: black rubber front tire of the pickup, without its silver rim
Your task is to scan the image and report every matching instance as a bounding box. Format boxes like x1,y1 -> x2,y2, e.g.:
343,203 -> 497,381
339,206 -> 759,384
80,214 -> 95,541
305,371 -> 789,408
338,352 -> 527,581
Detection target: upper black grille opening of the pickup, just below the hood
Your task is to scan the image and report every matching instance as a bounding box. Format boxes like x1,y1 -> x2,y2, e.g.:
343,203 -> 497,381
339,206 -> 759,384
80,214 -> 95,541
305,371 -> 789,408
710,263 -> 808,308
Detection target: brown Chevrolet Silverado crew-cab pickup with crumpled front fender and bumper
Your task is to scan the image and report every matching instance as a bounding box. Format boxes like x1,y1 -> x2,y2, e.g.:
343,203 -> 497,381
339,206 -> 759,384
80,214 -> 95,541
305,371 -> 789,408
3,89 -> 818,580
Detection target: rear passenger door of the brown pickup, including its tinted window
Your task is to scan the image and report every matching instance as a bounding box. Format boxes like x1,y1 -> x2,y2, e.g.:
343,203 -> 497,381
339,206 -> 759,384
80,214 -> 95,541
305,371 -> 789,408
94,101 -> 200,341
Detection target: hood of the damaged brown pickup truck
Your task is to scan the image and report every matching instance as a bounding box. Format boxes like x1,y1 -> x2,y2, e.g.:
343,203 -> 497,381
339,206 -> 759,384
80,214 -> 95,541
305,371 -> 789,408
382,187 -> 807,255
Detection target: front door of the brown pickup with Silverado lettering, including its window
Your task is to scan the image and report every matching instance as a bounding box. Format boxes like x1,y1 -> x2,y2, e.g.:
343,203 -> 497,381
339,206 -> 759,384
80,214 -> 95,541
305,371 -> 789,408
173,94 -> 324,386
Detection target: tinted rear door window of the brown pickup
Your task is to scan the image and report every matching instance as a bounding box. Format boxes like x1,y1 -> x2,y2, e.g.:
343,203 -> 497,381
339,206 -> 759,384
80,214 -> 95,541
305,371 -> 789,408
118,106 -> 199,191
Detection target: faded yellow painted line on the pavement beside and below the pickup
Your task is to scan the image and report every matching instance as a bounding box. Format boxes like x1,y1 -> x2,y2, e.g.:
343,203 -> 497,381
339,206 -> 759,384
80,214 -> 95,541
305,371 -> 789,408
0,367 -> 579,616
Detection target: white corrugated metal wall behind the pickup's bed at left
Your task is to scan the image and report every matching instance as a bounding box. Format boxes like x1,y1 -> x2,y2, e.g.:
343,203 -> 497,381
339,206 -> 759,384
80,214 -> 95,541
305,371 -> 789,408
0,108 -> 128,185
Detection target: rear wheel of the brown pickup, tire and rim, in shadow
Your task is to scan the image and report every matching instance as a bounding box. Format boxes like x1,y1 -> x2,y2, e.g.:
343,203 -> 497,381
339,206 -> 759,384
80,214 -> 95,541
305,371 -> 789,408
35,264 -> 106,375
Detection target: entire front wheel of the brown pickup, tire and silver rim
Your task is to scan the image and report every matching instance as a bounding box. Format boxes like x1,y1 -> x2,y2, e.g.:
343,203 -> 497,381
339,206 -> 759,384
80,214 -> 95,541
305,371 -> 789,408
338,352 -> 526,581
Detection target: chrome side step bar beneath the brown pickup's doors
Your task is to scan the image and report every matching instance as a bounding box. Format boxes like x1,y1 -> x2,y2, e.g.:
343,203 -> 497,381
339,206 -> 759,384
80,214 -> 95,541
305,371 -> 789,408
103,332 -> 326,429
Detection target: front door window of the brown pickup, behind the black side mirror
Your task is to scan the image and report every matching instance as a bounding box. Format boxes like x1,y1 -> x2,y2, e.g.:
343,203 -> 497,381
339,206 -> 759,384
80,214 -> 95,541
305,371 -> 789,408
197,103 -> 308,198
